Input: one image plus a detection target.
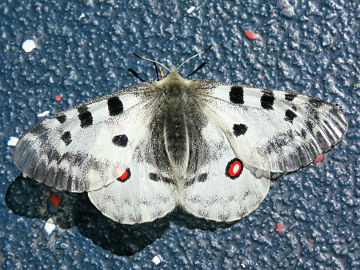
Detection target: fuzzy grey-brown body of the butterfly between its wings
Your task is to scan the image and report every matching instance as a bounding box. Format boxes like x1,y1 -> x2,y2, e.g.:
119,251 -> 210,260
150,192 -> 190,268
150,69 -> 204,178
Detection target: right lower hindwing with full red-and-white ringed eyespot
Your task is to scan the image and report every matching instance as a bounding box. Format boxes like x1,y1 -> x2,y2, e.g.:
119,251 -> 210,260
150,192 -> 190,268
179,121 -> 270,221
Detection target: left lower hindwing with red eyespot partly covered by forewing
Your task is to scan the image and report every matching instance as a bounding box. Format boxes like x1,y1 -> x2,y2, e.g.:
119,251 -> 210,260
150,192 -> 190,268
88,134 -> 176,224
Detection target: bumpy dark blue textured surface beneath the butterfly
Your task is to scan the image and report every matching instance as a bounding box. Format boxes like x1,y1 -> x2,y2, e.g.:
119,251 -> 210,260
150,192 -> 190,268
0,0 -> 360,270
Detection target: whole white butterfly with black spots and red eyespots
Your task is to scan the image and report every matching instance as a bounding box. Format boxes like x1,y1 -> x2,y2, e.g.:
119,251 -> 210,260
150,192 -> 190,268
14,46 -> 347,224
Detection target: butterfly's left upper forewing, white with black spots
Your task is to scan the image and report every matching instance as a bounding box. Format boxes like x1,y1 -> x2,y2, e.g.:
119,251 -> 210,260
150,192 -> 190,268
14,84 -> 160,192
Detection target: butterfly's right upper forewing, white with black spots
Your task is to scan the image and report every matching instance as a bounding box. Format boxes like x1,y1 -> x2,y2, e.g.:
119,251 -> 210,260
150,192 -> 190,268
195,80 -> 347,172
